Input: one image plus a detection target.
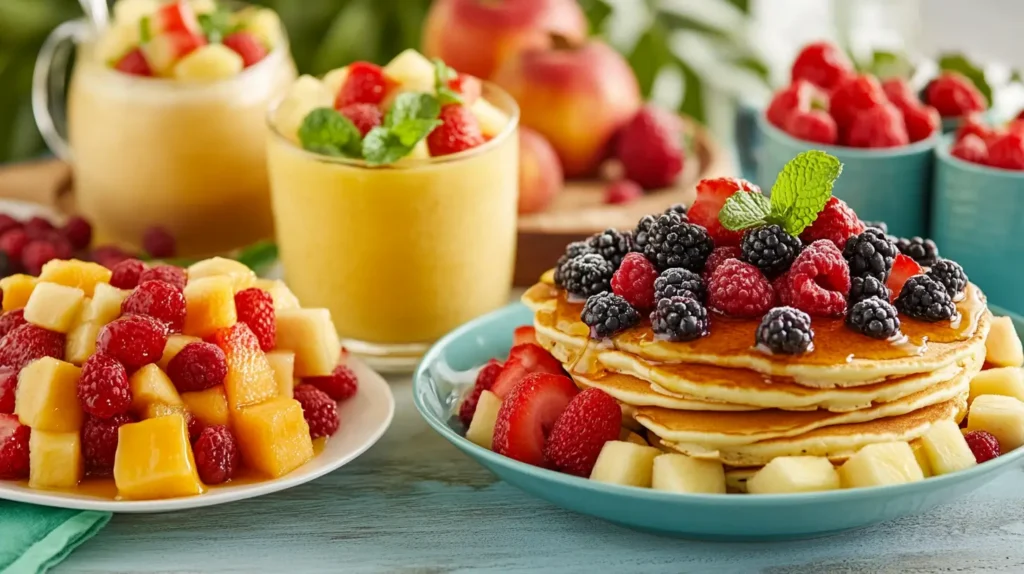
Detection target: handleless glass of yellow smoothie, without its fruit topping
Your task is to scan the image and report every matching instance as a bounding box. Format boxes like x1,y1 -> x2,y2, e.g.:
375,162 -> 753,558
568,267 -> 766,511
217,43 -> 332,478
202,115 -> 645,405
267,84 -> 519,371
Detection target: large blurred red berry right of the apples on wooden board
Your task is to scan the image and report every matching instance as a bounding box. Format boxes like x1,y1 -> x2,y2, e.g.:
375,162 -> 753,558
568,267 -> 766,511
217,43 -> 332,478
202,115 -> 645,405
615,105 -> 685,189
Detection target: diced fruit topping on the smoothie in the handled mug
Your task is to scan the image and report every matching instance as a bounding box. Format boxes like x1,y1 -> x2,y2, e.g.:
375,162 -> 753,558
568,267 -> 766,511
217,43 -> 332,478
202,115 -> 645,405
98,0 -> 284,82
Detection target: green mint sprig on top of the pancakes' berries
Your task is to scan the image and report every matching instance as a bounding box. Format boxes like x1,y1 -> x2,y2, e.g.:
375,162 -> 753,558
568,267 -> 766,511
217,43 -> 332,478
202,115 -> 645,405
718,149 -> 843,235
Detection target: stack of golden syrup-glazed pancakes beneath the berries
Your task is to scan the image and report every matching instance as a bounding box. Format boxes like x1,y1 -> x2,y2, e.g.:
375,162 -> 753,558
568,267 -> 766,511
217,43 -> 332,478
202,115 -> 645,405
522,273 -> 991,487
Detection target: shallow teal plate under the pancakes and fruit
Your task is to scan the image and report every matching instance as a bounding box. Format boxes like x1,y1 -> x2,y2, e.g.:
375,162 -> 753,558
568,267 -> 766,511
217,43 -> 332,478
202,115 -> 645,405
413,304 -> 1024,540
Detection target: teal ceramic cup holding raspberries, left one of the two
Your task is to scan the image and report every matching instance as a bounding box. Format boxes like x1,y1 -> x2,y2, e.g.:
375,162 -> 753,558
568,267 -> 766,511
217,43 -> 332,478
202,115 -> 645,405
756,114 -> 938,237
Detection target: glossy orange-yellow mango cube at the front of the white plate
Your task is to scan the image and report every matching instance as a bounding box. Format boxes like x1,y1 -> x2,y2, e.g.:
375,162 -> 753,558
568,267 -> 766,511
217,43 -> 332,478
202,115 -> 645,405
114,414 -> 203,499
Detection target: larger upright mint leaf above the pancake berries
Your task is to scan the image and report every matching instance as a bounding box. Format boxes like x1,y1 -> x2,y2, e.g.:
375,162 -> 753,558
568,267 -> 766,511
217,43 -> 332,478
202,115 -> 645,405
767,149 -> 843,235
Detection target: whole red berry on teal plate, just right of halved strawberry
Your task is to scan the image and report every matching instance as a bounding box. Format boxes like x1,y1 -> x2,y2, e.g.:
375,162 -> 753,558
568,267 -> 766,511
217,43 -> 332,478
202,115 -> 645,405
544,389 -> 623,478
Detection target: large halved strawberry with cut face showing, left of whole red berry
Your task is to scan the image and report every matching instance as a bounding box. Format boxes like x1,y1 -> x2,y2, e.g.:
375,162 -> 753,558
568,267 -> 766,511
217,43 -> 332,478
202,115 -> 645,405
493,372 -> 577,467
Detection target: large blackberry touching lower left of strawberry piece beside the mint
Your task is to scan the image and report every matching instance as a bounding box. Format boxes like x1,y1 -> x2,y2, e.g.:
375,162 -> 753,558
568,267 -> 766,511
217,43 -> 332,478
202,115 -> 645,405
643,215 -> 715,273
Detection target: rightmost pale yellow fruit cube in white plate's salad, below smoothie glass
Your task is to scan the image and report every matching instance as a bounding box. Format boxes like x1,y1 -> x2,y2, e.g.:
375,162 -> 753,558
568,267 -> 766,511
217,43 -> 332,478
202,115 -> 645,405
275,309 -> 341,377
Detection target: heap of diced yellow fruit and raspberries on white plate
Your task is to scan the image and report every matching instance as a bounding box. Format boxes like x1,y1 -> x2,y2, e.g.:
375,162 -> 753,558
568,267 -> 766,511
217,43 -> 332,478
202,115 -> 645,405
0,258 -> 358,499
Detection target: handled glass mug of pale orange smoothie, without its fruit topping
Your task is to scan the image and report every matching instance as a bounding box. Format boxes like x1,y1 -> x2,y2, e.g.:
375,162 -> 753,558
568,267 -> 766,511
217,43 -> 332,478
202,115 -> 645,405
33,3 -> 296,256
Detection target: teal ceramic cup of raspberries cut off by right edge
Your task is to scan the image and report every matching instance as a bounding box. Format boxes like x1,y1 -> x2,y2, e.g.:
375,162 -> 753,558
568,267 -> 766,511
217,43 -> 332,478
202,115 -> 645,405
932,134 -> 1024,313
